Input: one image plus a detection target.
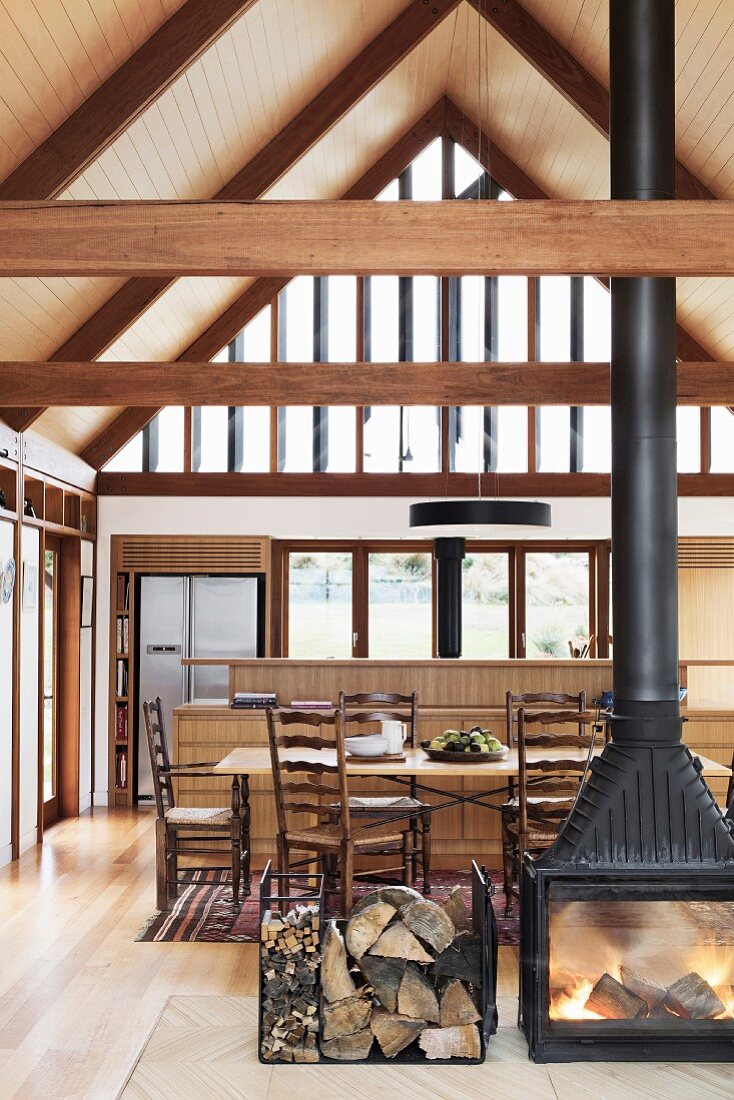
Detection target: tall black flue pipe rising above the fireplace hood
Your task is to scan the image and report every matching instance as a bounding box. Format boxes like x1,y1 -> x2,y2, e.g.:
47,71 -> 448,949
610,0 -> 681,741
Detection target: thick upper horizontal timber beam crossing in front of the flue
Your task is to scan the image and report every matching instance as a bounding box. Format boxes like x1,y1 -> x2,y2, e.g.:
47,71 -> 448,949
0,199 -> 734,277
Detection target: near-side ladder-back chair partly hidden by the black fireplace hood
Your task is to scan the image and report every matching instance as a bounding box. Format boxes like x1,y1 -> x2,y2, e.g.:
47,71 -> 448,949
505,707 -> 595,916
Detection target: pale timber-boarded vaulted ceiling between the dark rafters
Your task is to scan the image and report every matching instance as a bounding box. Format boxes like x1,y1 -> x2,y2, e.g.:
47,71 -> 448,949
0,0 -> 734,453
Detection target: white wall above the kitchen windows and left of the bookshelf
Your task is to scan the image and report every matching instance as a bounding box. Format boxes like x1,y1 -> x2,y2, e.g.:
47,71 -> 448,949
95,496 -> 734,805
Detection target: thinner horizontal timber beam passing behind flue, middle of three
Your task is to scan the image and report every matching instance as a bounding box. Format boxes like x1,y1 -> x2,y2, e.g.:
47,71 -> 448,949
5,360 -> 734,407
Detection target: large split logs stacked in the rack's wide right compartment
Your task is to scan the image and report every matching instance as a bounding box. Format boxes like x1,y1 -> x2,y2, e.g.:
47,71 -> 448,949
320,887 -> 482,1062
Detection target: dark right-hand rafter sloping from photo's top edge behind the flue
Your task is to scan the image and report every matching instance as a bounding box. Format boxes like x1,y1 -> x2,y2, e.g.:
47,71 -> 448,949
469,0 -> 716,199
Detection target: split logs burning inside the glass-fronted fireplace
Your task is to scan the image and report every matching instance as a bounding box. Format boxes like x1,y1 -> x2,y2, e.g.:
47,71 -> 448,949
585,966 -> 726,1020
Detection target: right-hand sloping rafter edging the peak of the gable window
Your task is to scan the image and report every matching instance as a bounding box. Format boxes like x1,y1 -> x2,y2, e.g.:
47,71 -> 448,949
445,97 -> 711,361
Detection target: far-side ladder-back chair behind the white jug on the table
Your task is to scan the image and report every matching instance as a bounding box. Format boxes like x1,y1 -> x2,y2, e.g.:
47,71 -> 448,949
339,691 -> 431,894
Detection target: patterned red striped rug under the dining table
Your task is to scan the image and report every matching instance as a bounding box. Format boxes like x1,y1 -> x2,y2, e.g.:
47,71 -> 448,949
136,871 -> 519,946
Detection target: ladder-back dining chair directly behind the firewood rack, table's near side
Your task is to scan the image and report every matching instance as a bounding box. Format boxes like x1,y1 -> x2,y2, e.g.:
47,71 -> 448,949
267,710 -> 410,917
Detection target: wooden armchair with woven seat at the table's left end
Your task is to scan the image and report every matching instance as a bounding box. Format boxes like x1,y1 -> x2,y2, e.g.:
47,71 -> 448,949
143,696 -> 250,911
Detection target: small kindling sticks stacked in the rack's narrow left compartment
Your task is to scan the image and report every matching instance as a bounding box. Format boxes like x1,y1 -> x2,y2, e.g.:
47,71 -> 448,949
260,905 -> 320,1062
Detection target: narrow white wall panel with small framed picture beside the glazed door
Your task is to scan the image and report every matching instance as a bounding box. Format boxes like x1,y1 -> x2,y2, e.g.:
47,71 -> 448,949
15,527 -> 43,853
